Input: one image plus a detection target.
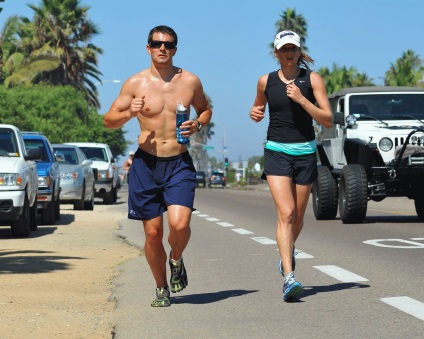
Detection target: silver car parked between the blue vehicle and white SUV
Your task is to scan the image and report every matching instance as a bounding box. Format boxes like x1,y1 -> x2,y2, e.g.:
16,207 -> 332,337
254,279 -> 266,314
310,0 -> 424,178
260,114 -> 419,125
52,144 -> 95,211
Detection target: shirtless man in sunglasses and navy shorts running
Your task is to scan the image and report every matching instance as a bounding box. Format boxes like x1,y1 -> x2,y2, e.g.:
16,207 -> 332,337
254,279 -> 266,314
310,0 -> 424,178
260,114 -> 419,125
104,26 -> 212,307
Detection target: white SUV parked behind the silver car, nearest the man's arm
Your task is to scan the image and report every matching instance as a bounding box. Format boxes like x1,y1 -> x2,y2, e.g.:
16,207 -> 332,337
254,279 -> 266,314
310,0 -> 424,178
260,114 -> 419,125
67,142 -> 119,204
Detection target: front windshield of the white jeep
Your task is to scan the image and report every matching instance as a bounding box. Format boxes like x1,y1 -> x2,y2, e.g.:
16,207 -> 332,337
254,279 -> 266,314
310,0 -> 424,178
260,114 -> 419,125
349,93 -> 424,124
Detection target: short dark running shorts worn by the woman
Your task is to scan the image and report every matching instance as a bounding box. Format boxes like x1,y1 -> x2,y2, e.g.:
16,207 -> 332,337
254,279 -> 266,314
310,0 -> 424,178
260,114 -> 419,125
262,148 -> 318,185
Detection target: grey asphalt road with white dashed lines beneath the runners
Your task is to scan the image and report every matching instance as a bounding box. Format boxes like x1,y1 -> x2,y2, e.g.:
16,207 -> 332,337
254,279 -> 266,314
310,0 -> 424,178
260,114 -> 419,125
114,188 -> 424,339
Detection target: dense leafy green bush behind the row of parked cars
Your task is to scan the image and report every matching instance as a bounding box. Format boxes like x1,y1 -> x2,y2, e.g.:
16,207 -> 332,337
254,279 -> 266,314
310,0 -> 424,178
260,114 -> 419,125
0,85 -> 128,156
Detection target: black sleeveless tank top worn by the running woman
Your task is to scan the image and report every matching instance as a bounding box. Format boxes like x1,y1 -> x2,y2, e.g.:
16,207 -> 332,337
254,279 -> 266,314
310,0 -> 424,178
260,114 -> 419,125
265,68 -> 316,143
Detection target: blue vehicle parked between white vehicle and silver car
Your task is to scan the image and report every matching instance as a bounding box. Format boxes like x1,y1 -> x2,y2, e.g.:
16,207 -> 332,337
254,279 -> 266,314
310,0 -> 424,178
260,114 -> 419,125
22,132 -> 60,225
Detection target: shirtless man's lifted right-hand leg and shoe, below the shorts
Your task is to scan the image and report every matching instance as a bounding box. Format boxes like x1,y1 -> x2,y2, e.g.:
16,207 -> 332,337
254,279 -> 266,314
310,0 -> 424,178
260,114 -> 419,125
168,205 -> 191,293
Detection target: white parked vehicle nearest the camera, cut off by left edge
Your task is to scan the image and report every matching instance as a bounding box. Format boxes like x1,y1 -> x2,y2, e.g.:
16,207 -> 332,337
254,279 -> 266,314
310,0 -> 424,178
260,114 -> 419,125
0,124 -> 41,237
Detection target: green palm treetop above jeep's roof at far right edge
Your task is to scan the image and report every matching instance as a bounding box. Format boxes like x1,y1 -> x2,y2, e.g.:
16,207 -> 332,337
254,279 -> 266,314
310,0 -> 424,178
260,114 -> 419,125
385,49 -> 424,86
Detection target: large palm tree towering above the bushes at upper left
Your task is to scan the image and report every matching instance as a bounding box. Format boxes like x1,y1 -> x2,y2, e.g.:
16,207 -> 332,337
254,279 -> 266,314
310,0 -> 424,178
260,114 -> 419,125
1,0 -> 103,108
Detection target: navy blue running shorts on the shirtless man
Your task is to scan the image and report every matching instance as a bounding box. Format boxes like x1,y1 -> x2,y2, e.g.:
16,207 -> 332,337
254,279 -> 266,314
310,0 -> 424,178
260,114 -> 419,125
128,149 -> 196,220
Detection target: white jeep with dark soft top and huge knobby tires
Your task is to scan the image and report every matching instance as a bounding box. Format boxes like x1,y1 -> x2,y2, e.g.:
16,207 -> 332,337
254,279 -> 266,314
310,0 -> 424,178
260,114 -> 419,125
312,87 -> 424,223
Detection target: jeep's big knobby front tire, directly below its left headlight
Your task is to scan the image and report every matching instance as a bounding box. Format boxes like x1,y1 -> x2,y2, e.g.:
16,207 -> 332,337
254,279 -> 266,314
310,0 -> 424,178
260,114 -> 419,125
339,165 -> 368,224
